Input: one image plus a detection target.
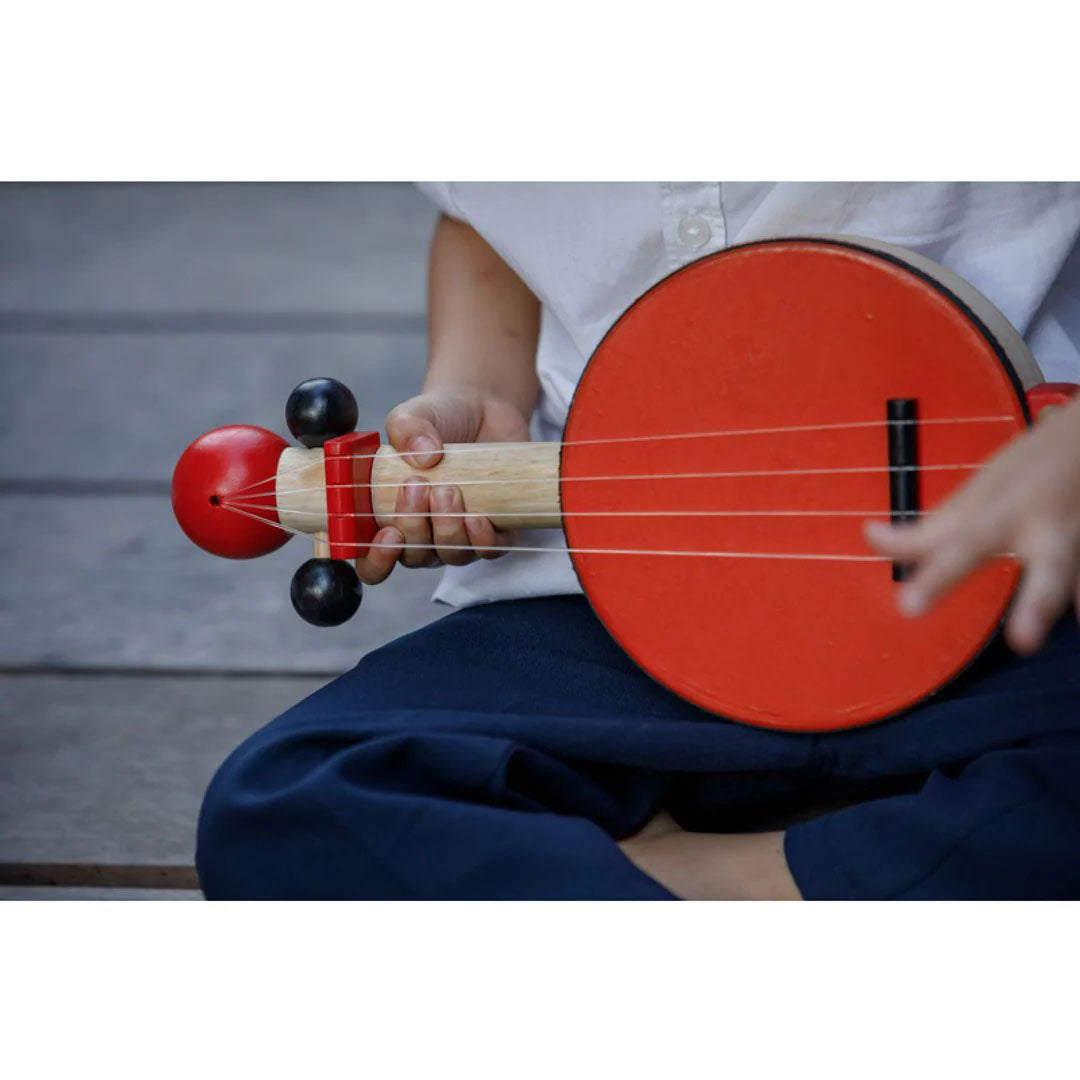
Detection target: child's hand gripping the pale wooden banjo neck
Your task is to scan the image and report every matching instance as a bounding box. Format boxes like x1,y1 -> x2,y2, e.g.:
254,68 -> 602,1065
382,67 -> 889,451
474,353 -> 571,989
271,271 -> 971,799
356,390 -> 529,585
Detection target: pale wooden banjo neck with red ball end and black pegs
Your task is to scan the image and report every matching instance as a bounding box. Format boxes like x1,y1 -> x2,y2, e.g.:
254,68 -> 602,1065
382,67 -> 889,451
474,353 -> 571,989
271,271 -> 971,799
173,379 -> 563,626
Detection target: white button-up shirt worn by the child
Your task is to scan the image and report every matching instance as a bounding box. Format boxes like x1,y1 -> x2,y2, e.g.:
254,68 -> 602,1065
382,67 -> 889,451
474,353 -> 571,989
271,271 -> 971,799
419,183 -> 1080,607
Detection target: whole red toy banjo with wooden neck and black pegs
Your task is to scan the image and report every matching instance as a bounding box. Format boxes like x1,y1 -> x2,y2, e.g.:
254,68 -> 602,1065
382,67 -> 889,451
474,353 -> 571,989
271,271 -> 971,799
173,238 -> 1074,731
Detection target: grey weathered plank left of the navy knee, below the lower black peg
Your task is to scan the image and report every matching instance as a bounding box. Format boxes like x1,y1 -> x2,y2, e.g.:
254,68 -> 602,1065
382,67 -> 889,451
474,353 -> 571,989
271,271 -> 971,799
0,676 -> 323,859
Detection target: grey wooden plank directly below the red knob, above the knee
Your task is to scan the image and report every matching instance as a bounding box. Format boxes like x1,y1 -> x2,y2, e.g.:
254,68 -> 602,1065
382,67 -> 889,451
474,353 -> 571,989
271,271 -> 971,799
0,496 -> 447,674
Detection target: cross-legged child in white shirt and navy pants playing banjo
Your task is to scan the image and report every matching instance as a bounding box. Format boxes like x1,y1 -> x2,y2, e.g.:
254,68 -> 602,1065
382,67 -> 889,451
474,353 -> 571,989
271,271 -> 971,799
198,184 -> 1080,899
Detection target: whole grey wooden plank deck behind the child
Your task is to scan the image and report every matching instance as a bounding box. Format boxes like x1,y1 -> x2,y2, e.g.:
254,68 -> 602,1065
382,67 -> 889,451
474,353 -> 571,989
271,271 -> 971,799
0,185 -> 440,899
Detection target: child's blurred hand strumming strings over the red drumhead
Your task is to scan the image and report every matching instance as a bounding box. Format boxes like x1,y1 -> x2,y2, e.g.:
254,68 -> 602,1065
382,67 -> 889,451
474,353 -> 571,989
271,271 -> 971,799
866,399 -> 1080,653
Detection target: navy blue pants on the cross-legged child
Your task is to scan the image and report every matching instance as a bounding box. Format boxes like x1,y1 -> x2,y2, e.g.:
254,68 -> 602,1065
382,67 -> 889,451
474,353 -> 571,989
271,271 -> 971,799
197,597 -> 1080,899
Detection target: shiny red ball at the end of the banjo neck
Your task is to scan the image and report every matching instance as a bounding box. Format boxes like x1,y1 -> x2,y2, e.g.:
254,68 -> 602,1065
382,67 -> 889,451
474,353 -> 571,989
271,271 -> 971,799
173,423 -> 289,558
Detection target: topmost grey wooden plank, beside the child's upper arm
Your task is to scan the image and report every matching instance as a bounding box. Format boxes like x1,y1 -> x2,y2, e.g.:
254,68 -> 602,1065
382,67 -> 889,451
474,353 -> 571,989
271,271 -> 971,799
0,184 -> 436,315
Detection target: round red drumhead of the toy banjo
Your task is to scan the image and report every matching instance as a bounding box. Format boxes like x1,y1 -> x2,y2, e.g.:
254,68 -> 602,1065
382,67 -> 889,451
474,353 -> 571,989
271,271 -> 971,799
561,241 -> 1026,731
